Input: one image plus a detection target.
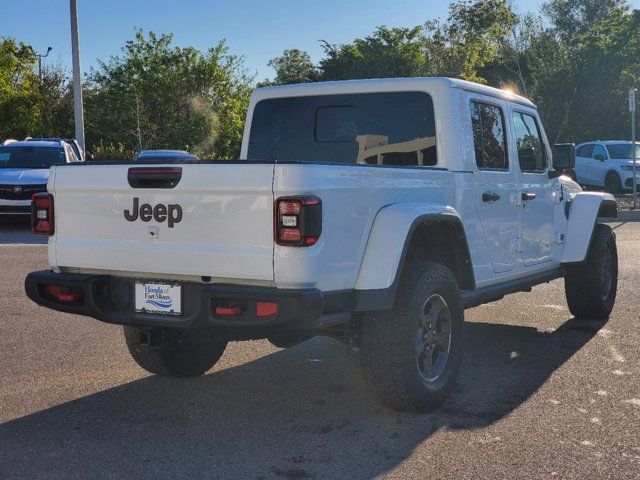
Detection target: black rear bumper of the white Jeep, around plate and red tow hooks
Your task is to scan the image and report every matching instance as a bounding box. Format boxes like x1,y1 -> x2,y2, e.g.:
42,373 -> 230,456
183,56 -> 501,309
25,270 -> 350,338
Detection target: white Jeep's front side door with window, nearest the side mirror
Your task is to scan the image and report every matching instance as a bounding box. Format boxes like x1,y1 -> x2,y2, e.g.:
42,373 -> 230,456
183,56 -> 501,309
511,110 -> 556,267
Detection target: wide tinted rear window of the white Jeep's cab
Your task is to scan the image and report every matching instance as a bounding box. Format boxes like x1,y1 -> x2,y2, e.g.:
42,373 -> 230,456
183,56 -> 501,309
247,92 -> 437,166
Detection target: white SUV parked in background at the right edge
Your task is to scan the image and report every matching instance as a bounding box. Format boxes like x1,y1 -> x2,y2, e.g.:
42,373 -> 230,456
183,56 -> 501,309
576,140 -> 640,193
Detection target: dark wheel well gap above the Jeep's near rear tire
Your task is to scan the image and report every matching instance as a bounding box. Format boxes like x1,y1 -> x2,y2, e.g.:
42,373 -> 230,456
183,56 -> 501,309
403,220 -> 475,290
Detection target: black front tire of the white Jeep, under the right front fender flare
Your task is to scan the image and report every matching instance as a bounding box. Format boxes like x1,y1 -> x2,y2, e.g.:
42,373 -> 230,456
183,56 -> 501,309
564,224 -> 618,320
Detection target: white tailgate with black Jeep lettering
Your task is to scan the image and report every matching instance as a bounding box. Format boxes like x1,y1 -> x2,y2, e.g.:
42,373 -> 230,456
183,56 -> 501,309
49,162 -> 273,281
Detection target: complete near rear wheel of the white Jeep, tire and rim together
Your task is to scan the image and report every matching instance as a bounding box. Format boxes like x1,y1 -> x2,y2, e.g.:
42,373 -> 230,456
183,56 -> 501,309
360,262 -> 464,412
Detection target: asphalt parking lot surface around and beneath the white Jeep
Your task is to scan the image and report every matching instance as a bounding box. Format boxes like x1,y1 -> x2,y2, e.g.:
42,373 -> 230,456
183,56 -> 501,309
0,222 -> 640,479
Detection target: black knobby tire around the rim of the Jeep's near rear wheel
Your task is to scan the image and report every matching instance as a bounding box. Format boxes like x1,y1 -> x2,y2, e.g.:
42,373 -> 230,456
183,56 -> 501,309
359,262 -> 464,412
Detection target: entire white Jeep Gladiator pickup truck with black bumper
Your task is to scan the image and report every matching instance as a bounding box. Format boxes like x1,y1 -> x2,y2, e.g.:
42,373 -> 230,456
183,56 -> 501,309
25,78 -> 618,411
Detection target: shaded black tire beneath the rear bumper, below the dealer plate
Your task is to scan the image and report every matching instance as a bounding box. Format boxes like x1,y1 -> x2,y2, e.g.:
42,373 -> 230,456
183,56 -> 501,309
124,326 -> 227,377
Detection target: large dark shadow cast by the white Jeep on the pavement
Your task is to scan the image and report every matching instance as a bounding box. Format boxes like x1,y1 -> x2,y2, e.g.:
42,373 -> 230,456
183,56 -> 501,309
0,319 -> 602,479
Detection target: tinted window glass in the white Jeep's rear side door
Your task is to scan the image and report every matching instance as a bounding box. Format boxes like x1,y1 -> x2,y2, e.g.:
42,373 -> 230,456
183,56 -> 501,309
471,101 -> 509,170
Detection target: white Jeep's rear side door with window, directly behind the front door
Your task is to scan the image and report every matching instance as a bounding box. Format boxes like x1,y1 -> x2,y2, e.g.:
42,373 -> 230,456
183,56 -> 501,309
470,99 -> 520,273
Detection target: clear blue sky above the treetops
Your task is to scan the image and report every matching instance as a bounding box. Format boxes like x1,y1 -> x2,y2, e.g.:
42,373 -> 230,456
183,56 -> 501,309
0,0 -> 640,81
